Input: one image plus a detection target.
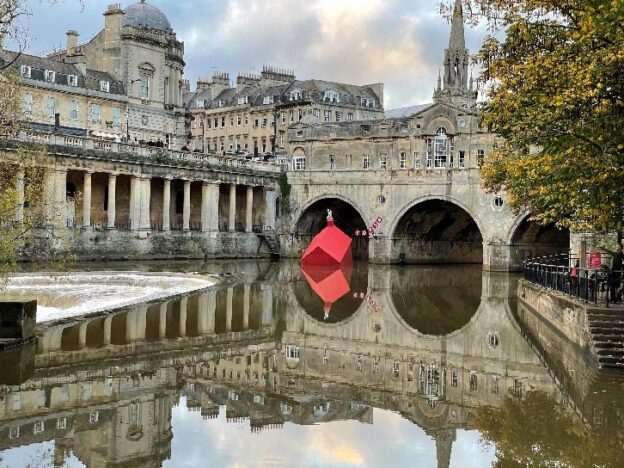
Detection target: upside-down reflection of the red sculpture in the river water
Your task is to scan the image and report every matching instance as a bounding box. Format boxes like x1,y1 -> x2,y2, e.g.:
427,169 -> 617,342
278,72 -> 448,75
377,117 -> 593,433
301,264 -> 353,320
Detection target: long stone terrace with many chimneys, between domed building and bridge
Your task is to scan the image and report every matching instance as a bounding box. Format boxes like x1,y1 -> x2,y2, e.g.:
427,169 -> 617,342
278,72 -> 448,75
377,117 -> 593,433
184,66 -> 384,159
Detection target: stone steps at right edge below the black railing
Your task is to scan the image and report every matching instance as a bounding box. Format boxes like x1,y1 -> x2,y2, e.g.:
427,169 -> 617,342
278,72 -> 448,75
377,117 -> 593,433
587,308 -> 624,369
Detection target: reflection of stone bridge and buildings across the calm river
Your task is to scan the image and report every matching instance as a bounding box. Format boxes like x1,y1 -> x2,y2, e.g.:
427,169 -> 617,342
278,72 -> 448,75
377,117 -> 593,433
0,262 -> 622,466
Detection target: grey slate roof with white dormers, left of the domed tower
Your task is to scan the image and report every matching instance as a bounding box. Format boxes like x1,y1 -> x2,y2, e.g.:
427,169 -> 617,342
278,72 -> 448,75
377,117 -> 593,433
0,50 -> 126,96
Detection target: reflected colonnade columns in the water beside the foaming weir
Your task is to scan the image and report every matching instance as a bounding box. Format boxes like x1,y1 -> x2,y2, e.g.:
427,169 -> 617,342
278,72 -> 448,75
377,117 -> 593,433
39,284 -> 273,353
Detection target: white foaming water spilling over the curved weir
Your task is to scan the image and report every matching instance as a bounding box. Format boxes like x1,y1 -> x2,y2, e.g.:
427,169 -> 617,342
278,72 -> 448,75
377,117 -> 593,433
0,272 -> 215,323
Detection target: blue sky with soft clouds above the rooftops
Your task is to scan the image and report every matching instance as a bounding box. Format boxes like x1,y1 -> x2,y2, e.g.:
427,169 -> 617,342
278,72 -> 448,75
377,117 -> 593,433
15,0 -> 486,109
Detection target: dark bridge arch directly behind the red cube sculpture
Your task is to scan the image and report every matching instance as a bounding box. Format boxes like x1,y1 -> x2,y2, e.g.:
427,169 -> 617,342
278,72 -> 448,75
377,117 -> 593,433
294,194 -> 369,259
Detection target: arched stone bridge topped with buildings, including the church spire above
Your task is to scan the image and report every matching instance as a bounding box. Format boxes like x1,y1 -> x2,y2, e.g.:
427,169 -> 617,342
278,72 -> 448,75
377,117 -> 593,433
280,0 -> 569,270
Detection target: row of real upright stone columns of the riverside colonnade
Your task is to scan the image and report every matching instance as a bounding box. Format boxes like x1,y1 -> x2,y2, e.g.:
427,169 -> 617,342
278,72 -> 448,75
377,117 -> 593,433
14,168 -> 277,232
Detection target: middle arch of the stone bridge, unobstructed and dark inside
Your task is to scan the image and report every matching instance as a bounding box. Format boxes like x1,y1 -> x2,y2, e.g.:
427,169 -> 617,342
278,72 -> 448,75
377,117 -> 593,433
389,195 -> 485,264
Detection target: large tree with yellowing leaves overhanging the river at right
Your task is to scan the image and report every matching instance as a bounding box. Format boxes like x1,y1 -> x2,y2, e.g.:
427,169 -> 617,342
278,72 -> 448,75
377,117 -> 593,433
454,0 -> 624,232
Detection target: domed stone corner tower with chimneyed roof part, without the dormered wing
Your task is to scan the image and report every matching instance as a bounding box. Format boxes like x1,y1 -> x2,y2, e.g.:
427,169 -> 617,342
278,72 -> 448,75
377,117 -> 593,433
49,0 -> 185,149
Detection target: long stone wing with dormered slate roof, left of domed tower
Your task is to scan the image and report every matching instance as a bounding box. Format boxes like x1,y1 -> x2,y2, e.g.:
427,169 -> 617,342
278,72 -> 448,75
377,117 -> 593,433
0,51 -> 128,141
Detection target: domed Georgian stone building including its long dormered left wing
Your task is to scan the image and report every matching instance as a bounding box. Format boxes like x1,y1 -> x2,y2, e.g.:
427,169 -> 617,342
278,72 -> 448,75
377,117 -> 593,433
15,0 -> 185,149
